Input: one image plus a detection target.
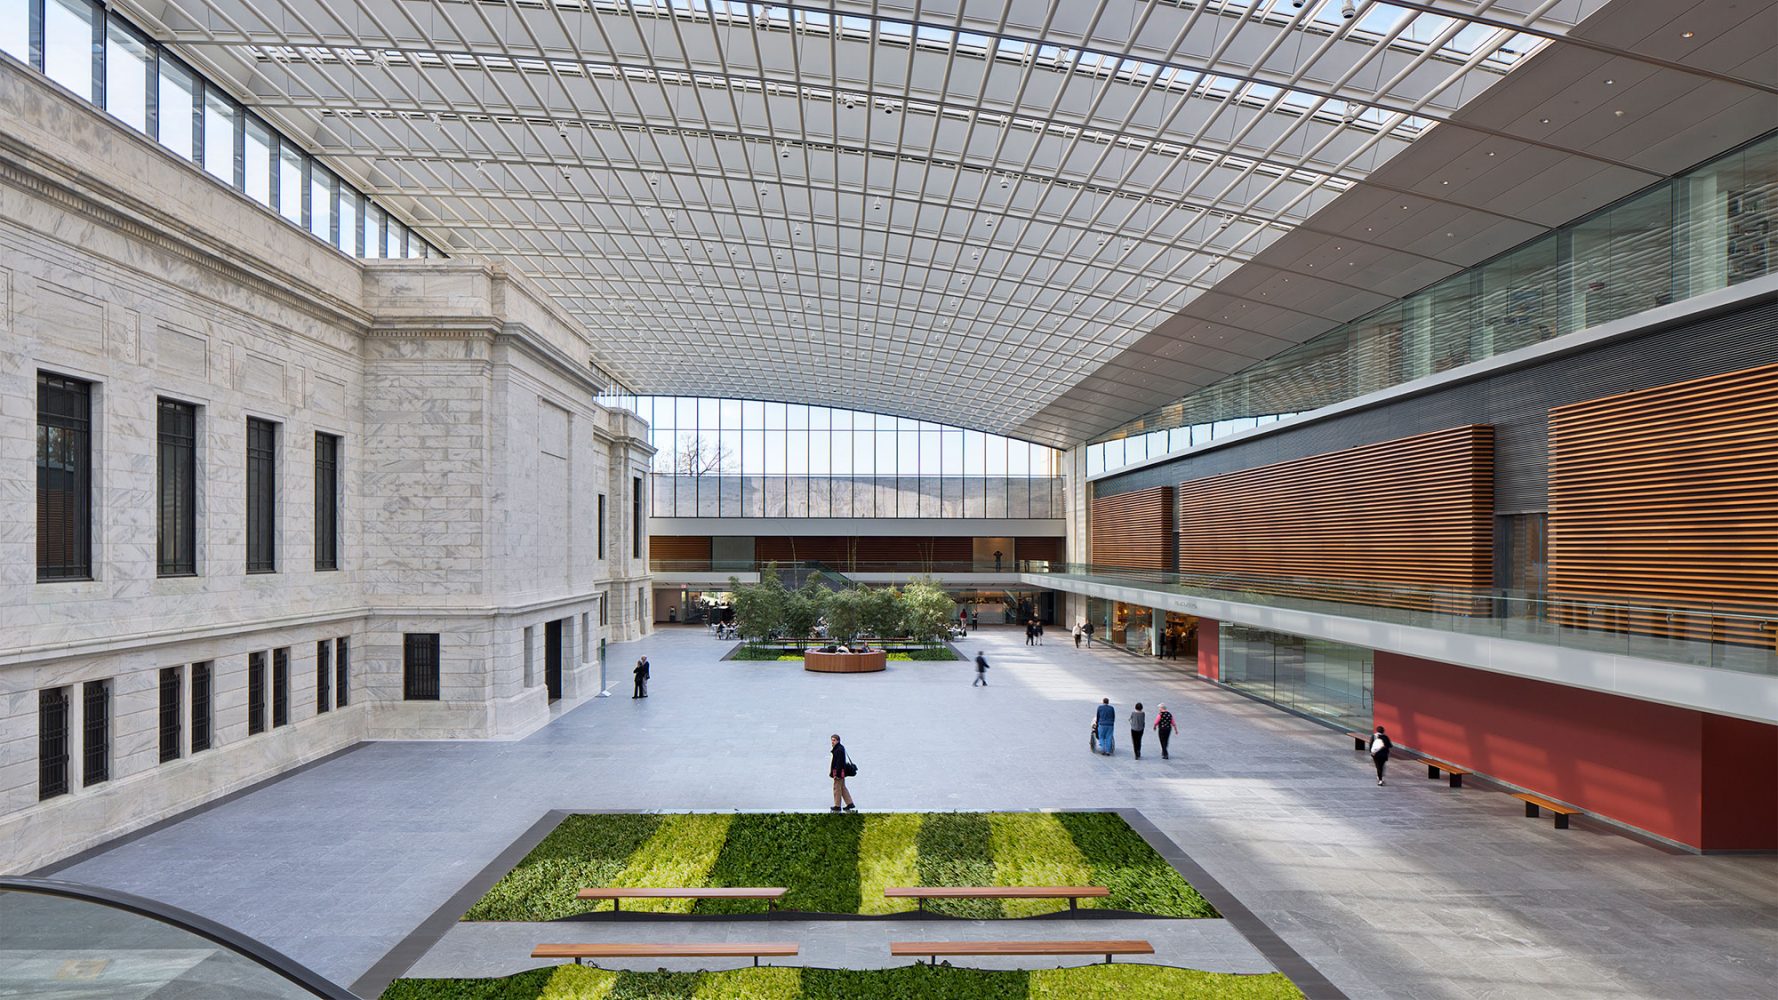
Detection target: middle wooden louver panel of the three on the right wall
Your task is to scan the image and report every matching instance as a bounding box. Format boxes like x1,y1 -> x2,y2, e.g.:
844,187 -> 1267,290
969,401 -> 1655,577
1177,423 -> 1494,612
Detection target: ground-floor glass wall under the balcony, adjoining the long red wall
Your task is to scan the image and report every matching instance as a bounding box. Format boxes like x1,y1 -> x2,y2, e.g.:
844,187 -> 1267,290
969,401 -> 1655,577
1218,623 -> 1374,731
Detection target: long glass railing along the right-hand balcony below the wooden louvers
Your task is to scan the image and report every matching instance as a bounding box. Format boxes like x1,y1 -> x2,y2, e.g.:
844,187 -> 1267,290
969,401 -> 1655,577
1022,562 -> 1778,674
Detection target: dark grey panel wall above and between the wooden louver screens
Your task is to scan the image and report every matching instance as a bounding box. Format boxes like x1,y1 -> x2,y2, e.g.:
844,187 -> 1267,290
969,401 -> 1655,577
1093,299 -> 1778,514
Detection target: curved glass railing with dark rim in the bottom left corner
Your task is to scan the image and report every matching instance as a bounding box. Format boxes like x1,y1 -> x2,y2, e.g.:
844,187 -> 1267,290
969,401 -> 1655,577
0,877 -> 357,1000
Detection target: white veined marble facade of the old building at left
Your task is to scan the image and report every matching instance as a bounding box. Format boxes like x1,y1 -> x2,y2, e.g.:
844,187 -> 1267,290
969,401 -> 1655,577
0,60 -> 651,872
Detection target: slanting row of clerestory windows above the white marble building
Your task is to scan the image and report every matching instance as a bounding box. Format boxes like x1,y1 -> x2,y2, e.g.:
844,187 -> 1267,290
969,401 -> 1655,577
0,0 -> 445,258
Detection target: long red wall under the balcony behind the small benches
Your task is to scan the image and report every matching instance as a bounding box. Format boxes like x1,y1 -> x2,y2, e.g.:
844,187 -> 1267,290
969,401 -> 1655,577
1374,651 -> 1778,851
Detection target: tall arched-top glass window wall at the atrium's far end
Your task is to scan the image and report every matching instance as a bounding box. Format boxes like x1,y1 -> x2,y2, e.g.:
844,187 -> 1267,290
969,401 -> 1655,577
635,397 -> 1063,518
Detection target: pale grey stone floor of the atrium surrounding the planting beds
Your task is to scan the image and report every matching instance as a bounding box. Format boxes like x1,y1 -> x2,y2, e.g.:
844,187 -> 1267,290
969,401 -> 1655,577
41,628 -> 1778,1000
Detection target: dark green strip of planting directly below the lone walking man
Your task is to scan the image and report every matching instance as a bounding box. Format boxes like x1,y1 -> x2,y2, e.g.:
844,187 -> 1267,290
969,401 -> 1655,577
695,813 -> 864,913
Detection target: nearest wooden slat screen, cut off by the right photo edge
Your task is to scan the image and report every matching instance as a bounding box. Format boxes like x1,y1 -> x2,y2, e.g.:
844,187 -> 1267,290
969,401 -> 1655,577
1549,365 -> 1778,644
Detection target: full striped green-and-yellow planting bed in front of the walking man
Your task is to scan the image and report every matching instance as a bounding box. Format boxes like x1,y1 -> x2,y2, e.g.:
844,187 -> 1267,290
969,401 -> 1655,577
462,813 -> 1216,920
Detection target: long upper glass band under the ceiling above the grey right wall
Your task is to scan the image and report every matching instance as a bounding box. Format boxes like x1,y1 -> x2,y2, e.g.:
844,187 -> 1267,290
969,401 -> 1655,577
1086,133 -> 1778,475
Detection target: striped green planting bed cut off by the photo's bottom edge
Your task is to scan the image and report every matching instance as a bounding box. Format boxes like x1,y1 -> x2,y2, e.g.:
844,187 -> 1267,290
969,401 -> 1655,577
382,963 -> 1303,1000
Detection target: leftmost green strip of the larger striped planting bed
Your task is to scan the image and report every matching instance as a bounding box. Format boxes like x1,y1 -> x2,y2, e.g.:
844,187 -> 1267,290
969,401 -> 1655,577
462,813 -> 661,920
